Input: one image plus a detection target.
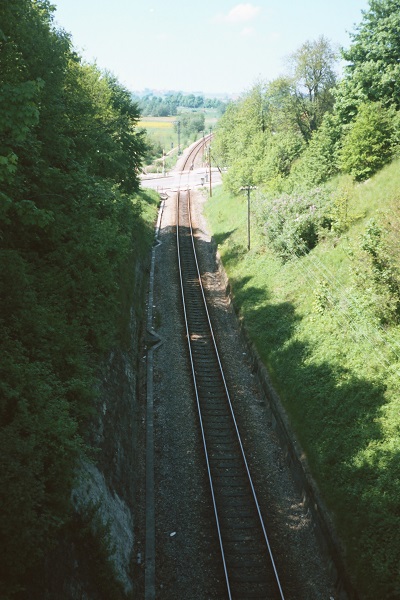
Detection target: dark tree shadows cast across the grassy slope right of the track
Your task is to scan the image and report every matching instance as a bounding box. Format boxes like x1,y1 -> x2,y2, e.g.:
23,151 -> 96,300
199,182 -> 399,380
187,226 -> 400,598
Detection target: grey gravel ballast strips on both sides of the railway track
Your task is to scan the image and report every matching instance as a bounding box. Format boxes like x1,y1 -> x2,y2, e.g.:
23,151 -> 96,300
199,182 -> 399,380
144,192 -> 338,600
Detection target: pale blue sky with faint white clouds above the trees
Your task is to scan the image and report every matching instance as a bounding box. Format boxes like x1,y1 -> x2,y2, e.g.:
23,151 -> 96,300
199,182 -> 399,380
53,0 -> 368,93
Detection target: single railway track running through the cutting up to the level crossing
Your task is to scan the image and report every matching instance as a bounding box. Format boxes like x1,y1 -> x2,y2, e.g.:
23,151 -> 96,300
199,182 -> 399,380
176,190 -> 284,600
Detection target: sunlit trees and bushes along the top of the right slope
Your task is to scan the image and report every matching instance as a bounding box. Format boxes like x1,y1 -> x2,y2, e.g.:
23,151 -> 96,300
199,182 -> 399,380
214,0 -> 400,194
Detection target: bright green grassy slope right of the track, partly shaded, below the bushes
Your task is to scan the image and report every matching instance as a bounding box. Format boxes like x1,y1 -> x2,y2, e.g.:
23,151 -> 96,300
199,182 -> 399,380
206,162 -> 400,599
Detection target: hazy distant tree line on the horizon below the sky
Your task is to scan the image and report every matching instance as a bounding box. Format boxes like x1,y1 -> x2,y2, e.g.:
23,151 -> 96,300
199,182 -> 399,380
132,92 -> 226,117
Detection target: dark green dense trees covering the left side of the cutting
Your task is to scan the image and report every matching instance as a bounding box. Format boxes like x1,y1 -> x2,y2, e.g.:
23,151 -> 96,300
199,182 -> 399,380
0,0 -> 155,598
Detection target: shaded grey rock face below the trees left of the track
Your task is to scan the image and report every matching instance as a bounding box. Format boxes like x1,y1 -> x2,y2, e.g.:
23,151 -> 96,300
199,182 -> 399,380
46,282 -> 145,600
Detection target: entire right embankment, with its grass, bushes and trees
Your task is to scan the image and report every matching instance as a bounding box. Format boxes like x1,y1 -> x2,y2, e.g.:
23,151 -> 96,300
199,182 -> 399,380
210,0 -> 400,600
